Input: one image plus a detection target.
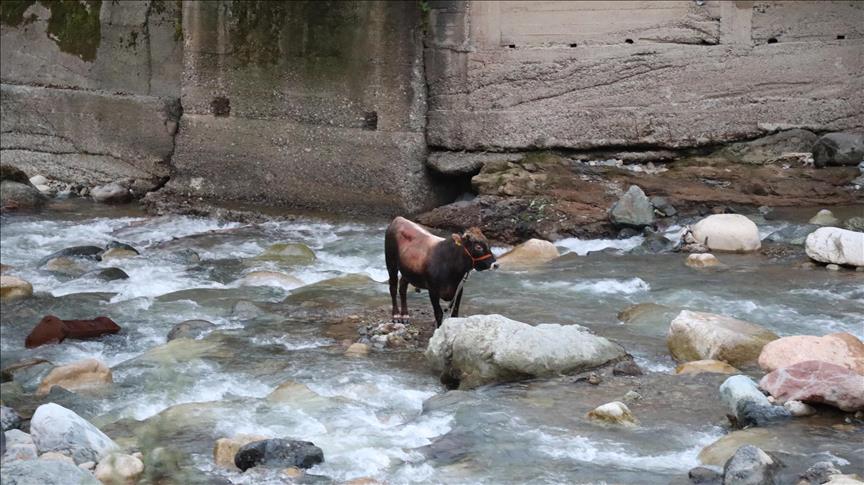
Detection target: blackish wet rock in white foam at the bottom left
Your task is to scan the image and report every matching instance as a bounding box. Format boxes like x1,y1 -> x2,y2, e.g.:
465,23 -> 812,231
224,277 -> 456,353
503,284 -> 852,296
234,438 -> 324,471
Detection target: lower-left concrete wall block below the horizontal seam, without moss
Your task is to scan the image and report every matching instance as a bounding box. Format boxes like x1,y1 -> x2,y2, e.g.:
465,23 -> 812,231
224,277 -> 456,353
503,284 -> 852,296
0,84 -> 180,184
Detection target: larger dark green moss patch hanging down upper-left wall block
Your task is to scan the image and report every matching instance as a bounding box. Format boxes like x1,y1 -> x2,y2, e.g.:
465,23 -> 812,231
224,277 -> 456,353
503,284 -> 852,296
39,0 -> 102,61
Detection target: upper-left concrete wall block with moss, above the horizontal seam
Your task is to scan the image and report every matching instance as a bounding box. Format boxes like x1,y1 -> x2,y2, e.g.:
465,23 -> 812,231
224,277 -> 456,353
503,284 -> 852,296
0,0 -> 183,97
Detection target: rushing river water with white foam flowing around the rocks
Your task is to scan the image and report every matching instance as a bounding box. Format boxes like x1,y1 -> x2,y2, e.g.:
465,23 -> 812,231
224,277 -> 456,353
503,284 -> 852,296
0,200 -> 864,483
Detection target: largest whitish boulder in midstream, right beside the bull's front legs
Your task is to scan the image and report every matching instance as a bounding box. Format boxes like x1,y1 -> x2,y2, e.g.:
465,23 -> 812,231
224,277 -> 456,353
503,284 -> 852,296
426,315 -> 627,389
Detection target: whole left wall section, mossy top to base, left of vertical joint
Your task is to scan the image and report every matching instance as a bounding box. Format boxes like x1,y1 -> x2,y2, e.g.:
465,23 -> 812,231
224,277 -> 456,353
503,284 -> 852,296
0,0 -> 182,185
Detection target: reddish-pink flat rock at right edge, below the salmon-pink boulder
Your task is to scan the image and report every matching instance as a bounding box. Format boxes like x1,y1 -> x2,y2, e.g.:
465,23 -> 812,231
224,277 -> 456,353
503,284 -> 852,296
759,360 -> 864,412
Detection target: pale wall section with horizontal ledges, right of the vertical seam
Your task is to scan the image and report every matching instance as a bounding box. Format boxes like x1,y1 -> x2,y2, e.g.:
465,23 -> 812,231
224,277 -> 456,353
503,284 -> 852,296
426,1 -> 864,151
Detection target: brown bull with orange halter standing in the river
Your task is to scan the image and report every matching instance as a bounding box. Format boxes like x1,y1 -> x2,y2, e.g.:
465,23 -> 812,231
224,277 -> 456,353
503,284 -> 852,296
384,217 -> 498,327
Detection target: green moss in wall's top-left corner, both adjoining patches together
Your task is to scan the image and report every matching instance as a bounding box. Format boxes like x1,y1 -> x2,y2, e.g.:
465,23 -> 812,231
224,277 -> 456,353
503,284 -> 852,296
0,0 -> 102,62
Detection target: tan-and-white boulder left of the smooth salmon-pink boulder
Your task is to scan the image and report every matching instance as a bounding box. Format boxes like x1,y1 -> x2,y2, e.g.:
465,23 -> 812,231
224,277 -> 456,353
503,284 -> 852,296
666,310 -> 778,366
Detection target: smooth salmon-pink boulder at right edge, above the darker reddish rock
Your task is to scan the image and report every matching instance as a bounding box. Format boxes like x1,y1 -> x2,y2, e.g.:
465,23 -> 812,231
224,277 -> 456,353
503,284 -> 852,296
759,333 -> 864,375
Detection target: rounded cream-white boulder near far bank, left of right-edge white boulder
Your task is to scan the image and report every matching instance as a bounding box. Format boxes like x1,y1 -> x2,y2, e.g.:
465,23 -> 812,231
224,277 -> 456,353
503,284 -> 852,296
690,214 -> 762,252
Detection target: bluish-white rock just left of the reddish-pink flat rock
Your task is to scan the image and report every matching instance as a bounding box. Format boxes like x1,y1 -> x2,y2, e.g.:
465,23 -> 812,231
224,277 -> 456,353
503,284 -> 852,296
720,375 -> 791,427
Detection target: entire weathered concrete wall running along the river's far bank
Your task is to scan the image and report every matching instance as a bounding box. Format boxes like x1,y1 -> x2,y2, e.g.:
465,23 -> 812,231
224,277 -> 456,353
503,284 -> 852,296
0,0 -> 864,213
